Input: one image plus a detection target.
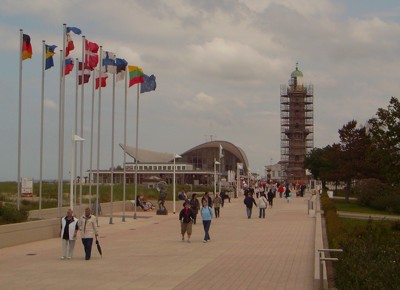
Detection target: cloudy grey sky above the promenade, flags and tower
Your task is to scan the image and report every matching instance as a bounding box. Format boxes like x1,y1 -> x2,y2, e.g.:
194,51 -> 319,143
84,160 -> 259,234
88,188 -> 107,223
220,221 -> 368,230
0,0 -> 400,180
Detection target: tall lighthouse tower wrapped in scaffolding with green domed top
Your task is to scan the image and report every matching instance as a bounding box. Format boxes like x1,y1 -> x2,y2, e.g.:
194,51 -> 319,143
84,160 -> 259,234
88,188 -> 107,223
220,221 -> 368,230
280,64 -> 314,183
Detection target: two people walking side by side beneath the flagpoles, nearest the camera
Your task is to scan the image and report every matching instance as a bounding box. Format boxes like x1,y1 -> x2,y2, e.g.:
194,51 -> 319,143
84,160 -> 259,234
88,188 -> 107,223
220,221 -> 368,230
59,208 -> 98,260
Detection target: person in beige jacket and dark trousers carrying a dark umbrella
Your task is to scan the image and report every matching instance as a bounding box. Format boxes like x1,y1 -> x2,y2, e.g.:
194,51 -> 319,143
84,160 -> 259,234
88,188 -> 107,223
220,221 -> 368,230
79,207 -> 99,260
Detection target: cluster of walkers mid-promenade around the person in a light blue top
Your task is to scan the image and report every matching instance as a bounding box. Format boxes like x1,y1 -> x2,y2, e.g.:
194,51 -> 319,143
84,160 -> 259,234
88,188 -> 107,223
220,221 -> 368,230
179,192 -> 230,243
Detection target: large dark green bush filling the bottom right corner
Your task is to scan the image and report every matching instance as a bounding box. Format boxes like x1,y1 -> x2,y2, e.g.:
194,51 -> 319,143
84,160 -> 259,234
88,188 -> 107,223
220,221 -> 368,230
335,221 -> 400,290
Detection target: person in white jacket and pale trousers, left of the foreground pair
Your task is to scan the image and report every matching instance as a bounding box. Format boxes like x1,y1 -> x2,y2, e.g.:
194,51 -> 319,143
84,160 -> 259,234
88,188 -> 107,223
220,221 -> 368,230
59,208 -> 78,260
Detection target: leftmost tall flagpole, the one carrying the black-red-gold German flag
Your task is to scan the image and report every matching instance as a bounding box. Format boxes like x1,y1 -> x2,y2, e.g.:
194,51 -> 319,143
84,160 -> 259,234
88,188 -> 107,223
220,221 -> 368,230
17,29 -> 23,210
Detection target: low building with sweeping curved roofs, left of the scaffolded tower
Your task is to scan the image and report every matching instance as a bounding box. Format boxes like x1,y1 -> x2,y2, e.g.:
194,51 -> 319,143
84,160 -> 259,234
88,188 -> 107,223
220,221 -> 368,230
98,140 -> 249,184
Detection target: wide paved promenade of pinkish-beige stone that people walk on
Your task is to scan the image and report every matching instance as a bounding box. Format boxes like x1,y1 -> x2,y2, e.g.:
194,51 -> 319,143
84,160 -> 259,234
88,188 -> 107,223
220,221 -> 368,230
0,197 -> 315,290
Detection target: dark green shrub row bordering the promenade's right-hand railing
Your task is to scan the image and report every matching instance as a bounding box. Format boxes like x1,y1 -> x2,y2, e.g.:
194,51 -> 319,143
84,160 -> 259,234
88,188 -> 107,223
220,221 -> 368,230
321,191 -> 400,290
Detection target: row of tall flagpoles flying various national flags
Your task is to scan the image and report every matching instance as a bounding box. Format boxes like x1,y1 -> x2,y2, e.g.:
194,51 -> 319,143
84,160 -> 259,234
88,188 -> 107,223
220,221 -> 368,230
17,24 -> 156,223
